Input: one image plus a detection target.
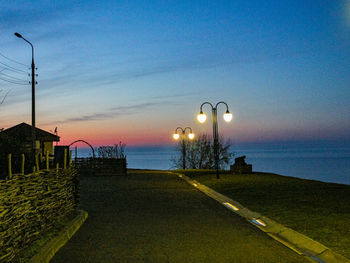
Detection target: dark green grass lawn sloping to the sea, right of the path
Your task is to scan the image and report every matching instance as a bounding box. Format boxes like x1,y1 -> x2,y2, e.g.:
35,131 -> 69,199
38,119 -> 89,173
177,170 -> 350,258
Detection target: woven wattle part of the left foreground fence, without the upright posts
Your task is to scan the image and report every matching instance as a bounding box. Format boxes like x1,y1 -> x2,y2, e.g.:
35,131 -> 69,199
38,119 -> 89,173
0,167 -> 79,262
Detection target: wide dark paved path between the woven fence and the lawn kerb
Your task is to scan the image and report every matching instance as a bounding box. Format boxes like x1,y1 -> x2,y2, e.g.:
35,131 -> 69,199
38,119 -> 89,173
51,172 -> 307,263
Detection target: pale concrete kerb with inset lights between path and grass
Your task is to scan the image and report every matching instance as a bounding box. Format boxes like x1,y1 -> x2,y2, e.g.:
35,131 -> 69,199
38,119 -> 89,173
173,173 -> 350,263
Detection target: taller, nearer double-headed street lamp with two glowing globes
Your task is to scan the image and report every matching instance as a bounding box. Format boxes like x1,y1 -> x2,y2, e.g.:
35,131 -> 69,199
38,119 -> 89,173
197,101 -> 232,179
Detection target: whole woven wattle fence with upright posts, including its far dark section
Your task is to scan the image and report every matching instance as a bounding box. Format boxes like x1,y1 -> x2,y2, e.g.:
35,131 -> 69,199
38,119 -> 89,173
0,153 -> 127,262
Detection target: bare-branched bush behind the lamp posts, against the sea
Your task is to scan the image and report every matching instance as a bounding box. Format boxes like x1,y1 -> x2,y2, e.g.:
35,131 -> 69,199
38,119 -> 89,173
171,134 -> 234,169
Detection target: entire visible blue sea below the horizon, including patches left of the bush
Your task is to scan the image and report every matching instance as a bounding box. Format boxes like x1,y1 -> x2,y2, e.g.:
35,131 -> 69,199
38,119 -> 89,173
71,146 -> 350,185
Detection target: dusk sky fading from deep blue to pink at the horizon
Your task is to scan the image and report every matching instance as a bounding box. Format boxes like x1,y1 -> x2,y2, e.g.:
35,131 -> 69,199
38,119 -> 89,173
0,0 -> 350,146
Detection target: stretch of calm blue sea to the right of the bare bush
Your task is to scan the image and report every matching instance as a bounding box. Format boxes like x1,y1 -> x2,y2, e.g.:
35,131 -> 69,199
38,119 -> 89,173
232,148 -> 350,184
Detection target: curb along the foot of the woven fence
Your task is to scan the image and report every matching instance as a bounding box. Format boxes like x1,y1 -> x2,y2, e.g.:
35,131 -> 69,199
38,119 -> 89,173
29,210 -> 88,263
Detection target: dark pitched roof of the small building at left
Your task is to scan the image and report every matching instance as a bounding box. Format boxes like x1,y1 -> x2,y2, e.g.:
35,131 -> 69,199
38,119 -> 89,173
0,122 -> 60,142
